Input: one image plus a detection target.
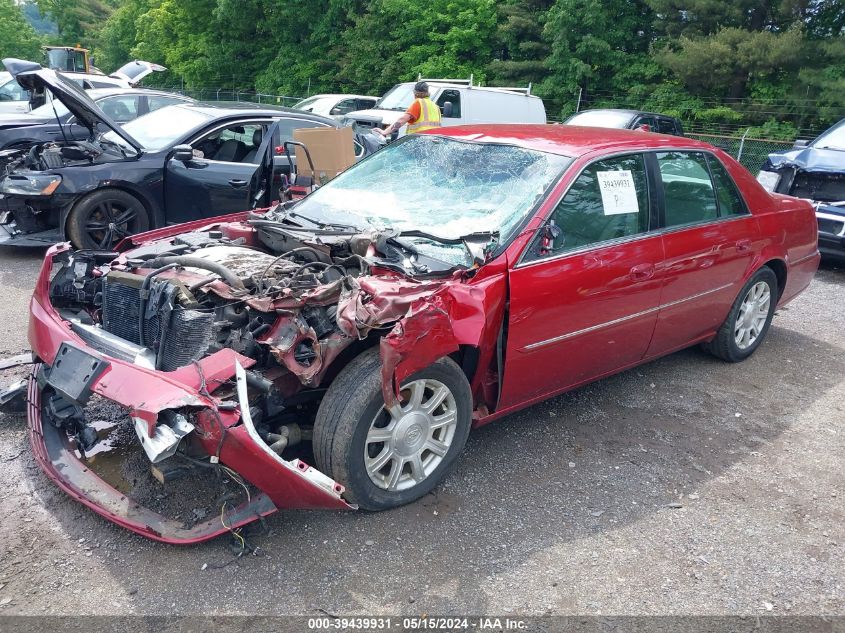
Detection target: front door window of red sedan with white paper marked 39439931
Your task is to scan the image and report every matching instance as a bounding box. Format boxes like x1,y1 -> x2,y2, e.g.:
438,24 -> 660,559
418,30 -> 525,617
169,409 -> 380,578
536,154 -> 649,254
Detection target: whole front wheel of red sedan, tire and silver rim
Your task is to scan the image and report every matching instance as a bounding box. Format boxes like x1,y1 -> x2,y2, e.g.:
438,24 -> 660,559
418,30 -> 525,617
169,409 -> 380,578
313,348 -> 472,510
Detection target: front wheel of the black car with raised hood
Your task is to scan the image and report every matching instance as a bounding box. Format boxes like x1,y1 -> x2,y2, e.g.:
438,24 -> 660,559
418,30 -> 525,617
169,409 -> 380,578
66,189 -> 150,249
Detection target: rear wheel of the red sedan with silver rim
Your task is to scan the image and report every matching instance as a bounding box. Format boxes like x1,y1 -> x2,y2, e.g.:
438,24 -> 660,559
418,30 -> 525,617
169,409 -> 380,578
701,266 -> 778,363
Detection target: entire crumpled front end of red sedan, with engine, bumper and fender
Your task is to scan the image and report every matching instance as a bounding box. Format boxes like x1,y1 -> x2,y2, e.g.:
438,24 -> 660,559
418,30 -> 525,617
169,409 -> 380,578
23,216 -> 506,543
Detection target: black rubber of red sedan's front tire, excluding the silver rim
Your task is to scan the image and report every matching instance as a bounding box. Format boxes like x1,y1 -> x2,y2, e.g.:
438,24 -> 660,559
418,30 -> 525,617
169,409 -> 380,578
313,347 -> 472,510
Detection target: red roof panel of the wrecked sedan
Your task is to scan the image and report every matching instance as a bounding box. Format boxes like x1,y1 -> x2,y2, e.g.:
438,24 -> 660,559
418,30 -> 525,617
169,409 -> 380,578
425,123 -> 712,158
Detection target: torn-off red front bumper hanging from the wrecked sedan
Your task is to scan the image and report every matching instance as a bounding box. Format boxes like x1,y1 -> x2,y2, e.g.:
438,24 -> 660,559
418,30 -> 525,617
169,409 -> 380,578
27,245 -> 351,543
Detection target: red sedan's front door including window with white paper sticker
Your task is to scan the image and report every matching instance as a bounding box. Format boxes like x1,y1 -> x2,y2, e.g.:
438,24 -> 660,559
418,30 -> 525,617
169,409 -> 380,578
500,154 -> 663,408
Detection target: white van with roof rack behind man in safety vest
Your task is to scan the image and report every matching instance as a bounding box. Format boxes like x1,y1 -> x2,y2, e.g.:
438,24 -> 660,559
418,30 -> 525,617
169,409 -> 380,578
343,77 -> 546,135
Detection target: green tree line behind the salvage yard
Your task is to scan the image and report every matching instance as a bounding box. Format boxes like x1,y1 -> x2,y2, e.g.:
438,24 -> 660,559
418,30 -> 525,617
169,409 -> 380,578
0,0 -> 845,137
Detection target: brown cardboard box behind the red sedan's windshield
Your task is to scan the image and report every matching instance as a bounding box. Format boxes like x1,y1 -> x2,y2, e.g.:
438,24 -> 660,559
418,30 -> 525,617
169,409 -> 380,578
293,127 -> 355,185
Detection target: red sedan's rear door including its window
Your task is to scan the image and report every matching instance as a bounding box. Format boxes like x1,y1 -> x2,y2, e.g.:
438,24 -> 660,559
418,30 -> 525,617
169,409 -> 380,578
648,151 -> 759,356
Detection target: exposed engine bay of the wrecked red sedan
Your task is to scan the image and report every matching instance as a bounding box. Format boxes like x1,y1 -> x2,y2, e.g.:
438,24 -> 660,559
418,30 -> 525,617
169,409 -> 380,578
44,202 -> 472,470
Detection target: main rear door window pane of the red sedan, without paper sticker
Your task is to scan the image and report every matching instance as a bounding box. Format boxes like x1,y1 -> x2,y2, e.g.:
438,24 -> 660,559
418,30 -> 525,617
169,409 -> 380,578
657,152 -> 718,226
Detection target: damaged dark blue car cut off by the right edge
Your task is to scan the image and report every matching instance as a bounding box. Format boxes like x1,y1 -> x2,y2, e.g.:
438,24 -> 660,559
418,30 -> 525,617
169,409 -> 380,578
757,119 -> 845,260
